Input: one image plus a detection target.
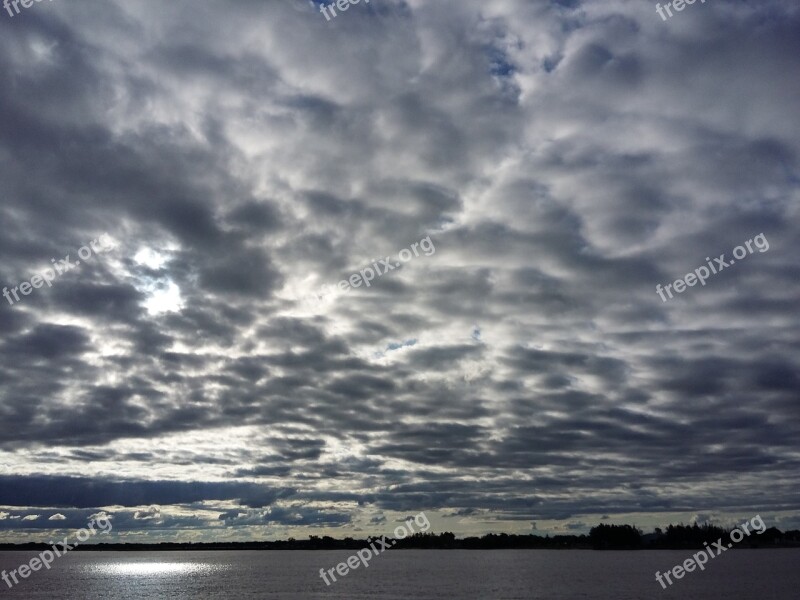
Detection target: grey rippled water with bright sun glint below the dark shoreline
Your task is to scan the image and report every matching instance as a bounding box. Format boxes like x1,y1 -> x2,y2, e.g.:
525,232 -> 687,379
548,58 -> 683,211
0,549 -> 800,600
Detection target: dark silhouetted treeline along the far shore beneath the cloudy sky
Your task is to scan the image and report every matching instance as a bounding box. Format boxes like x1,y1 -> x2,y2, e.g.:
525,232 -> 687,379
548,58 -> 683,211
0,524 -> 800,552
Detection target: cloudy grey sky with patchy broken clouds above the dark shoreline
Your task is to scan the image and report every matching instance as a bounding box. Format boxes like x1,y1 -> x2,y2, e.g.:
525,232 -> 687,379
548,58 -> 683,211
0,0 -> 800,541
